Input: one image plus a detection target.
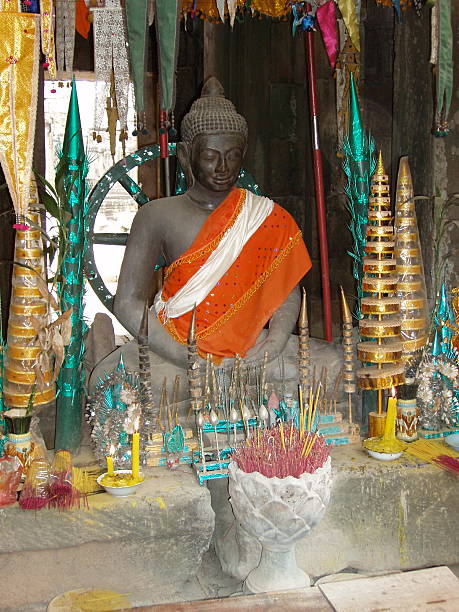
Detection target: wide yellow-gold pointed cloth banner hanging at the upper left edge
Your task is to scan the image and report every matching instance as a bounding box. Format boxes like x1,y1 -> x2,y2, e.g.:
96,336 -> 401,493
0,12 -> 40,216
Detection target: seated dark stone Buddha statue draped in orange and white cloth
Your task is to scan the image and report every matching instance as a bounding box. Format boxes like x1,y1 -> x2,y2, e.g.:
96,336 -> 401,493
90,78 -> 342,399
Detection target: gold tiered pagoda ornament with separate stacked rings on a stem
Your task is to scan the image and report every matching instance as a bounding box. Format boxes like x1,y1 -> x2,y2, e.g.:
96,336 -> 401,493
357,153 -> 405,406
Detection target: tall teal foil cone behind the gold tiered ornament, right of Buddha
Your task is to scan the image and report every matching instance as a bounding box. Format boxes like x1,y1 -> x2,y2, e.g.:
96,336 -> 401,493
342,73 -> 376,319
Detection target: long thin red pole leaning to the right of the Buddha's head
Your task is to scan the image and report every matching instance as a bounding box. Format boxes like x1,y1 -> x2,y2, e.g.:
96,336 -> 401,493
305,21 -> 333,342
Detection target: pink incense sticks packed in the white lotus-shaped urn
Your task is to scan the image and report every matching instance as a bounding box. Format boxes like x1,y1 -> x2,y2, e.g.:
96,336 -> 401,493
233,422 -> 330,478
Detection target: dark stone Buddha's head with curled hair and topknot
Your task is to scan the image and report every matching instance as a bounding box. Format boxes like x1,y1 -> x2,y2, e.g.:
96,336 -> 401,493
177,77 -> 247,192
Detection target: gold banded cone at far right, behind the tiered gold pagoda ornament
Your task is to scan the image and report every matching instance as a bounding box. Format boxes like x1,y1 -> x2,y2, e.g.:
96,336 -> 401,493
395,157 -> 428,378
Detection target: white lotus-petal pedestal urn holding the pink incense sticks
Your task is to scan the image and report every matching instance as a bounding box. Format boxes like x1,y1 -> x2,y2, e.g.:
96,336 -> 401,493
229,457 -> 331,593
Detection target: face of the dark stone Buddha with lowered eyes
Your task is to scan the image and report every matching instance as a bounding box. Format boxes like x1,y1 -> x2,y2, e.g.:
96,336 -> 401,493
191,132 -> 246,192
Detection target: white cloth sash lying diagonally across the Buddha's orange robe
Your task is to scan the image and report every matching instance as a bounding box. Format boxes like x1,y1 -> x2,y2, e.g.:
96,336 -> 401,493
154,191 -> 274,320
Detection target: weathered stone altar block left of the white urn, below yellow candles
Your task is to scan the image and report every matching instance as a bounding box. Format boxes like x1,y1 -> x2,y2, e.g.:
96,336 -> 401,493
0,468 -> 214,612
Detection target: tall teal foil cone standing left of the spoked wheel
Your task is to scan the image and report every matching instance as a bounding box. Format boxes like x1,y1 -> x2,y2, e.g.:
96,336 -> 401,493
56,79 -> 88,451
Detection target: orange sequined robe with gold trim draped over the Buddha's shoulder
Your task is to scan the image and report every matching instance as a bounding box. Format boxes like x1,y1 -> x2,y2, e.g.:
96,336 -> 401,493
158,188 -> 311,357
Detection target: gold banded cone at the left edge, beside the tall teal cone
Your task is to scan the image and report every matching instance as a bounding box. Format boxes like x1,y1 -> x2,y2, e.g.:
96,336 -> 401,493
4,182 -> 56,408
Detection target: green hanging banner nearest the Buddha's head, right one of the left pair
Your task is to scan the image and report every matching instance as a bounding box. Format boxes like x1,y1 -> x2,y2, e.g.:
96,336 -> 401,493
156,0 -> 180,111
